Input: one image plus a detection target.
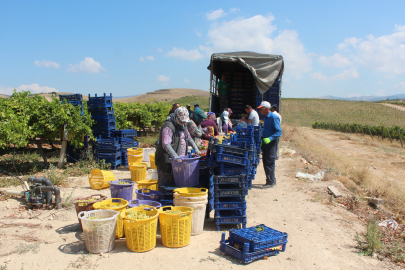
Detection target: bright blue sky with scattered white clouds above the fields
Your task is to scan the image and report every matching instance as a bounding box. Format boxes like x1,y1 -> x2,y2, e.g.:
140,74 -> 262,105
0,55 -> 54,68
0,0 -> 405,97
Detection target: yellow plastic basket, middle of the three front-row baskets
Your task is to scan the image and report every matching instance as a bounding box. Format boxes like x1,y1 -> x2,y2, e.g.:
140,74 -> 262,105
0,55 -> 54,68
120,206 -> 159,252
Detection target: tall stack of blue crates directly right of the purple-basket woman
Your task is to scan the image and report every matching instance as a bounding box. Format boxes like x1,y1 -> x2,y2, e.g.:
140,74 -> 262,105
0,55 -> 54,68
207,139 -> 256,230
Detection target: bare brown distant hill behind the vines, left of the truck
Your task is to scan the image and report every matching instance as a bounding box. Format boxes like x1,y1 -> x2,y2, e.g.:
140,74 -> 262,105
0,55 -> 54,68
114,88 -> 210,103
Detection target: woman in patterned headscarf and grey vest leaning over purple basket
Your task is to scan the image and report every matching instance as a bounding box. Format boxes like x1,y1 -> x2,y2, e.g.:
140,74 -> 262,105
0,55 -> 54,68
155,107 -> 200,186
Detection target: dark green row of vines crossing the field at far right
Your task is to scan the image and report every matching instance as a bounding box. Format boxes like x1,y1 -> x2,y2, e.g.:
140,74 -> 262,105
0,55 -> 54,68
312,122 -> 405,142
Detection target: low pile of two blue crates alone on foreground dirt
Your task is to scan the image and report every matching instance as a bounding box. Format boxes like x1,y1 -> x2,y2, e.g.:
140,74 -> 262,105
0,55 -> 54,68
220,224 -> 288,264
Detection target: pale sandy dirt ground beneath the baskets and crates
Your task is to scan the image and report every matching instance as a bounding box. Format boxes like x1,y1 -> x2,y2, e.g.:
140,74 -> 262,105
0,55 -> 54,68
0,142 -> 399,269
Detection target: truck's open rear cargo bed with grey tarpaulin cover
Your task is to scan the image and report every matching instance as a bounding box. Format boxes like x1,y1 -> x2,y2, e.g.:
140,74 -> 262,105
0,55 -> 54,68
208,52 -> 284,119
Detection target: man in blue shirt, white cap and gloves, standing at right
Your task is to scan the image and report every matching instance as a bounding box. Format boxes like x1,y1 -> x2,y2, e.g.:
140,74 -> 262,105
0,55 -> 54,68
257,101 -> 282,188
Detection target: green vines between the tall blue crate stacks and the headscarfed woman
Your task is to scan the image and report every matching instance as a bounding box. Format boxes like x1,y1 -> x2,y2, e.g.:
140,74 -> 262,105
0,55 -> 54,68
114,101 -> 171,130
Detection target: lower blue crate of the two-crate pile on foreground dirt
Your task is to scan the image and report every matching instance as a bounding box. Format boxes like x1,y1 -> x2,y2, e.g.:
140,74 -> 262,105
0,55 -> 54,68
219,233 -> 280,264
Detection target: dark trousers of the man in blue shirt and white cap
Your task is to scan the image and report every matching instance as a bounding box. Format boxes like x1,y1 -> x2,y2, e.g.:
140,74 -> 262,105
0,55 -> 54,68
262,138 -> 278,185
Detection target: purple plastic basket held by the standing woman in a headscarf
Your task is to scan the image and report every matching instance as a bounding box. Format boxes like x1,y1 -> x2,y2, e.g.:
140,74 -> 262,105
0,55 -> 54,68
171,156 -> 200,187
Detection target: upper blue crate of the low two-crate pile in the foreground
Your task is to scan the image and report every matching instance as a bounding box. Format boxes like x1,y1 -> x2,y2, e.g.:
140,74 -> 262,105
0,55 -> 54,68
229,224 -> 288,252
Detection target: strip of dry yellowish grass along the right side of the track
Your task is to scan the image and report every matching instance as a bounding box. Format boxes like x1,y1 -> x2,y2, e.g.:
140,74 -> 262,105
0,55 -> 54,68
283,125 -> 405,218
